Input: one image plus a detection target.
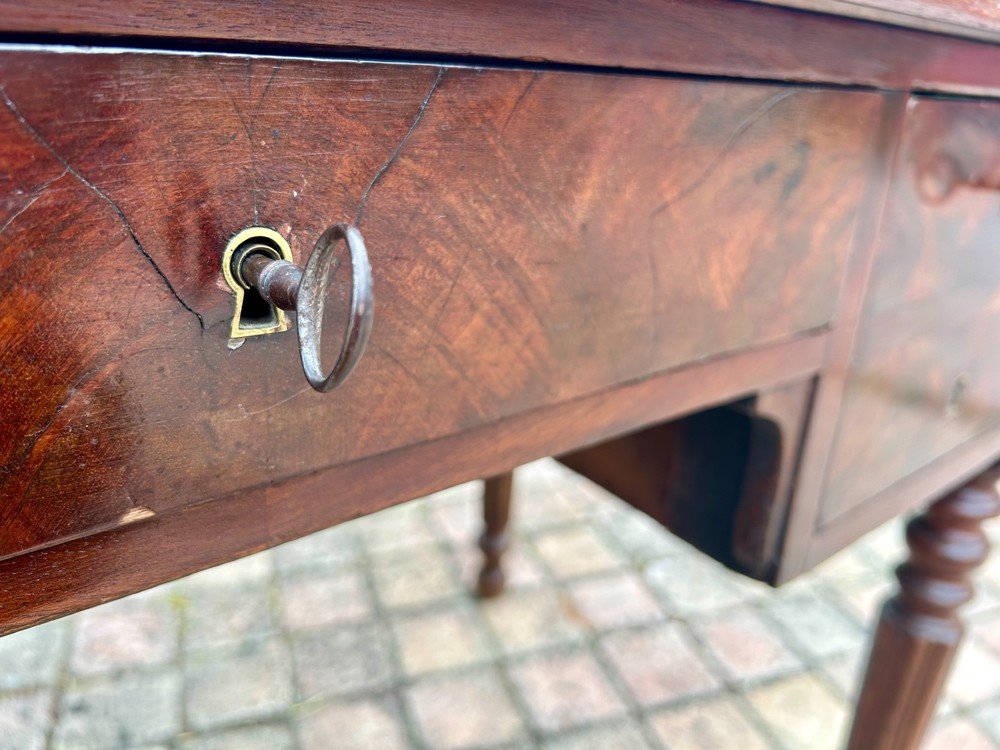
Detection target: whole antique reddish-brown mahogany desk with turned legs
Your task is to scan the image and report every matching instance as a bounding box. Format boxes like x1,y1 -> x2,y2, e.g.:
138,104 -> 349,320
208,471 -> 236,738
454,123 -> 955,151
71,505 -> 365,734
0,0 -> 1000,750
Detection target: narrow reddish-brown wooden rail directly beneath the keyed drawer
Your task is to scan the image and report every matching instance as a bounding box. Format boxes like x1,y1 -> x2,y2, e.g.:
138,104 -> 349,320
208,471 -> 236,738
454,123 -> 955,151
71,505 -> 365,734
0,334 -> 827,635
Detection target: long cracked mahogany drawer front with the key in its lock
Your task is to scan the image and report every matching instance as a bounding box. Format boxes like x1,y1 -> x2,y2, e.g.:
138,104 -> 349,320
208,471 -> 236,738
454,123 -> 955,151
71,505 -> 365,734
0,51 -> 881,555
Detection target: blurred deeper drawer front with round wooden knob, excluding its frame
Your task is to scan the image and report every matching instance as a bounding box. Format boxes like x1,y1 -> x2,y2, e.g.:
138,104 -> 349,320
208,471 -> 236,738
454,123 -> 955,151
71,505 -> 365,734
821,98 -> 1000,521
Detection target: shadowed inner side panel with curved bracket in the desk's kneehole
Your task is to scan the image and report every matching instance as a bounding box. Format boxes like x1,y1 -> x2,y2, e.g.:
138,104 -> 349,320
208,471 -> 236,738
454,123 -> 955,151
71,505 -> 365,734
559,380 -> 813,581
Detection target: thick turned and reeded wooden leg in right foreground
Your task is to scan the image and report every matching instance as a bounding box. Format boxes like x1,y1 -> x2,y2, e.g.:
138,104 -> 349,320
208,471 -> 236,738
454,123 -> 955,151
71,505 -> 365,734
848,469 -> 1000,750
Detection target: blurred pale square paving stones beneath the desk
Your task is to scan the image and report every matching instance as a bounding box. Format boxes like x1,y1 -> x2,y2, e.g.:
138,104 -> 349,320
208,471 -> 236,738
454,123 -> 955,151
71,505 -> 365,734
0,461 -> 1000,750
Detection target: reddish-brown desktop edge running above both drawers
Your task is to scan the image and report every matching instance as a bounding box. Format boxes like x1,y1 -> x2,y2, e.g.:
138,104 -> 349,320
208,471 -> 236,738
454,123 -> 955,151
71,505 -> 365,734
0,0 -> 1000,95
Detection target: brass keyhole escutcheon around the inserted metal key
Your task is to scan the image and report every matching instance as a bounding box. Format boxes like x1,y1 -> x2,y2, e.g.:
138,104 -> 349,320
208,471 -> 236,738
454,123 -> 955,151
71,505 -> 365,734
222,227 -> 292,339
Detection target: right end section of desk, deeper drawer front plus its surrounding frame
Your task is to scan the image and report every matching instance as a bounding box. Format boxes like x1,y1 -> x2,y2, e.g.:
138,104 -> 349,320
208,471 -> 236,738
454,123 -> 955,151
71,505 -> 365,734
779,97 -> 1000,580
